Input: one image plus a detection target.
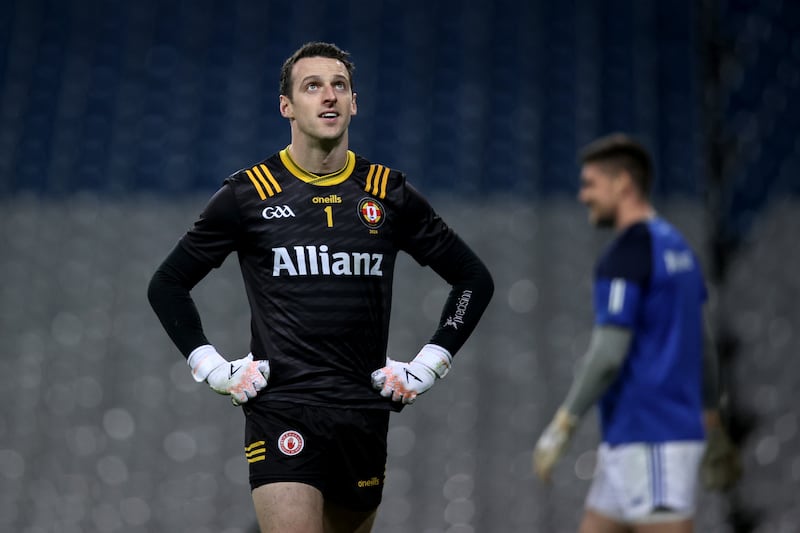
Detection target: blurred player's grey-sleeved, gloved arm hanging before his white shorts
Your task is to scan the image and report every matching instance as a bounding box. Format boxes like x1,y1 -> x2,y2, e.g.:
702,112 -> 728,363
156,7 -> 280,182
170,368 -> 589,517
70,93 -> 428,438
533,325 -> 633,480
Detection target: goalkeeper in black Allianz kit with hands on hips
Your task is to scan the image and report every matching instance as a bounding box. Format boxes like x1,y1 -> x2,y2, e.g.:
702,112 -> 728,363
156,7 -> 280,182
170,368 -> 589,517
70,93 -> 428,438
148,42 -> 493,533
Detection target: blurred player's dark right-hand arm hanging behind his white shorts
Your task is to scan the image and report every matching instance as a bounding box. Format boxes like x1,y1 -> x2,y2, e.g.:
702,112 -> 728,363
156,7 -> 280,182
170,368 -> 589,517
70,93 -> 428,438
700,312 -> 742,490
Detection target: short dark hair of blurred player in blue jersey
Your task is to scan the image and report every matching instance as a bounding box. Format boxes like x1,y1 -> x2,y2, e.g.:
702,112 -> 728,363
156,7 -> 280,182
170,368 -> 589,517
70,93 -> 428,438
580,133 -> 653,197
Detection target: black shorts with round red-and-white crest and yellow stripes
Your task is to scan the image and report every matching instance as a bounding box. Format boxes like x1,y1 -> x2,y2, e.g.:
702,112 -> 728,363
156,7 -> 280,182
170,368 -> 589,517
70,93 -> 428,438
243,402 -> 389,511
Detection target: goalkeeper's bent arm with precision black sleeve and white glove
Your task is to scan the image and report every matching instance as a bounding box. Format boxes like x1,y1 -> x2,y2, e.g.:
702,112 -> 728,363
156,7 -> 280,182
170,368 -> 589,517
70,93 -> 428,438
372,235 -> 494,404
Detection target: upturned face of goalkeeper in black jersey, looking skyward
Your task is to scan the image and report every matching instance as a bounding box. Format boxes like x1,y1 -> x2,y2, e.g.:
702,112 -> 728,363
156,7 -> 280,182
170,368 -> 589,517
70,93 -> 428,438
280,57 -> 356,140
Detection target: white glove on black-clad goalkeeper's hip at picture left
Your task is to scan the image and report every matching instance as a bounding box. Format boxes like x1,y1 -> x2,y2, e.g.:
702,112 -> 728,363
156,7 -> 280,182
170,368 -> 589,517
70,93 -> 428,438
188,344 -> 269,405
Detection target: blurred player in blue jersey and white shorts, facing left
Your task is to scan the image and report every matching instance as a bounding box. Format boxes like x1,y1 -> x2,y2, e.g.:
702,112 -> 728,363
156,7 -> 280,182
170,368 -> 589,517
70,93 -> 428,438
533,134 -> 739,533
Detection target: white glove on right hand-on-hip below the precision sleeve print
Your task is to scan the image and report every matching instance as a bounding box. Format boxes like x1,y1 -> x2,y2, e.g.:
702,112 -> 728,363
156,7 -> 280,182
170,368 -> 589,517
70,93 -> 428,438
372,344 -> 453,404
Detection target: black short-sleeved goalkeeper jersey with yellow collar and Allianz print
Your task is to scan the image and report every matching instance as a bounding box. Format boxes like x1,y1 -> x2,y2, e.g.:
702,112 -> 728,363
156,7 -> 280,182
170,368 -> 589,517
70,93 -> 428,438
180,150 -> 458,408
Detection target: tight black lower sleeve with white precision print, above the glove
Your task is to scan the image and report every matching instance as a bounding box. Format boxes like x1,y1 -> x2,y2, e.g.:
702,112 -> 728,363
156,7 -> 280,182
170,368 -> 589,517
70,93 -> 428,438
430,235 -> 494,355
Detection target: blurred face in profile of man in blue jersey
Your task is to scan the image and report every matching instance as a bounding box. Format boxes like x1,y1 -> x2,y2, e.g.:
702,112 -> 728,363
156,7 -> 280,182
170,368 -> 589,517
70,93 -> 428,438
578,163 -> 623,227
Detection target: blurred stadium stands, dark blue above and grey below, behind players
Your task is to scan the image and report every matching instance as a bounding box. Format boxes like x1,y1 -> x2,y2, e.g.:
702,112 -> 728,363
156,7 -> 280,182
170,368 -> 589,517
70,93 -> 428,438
0,0 -> 800,533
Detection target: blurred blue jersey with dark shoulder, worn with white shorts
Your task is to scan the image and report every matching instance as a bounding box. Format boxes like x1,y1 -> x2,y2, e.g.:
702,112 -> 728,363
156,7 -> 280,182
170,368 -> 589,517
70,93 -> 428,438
594,218 -> 707,445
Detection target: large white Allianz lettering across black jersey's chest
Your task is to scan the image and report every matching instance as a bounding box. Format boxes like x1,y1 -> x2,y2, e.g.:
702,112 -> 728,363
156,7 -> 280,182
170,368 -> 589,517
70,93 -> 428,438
272,244 -> 383,277
